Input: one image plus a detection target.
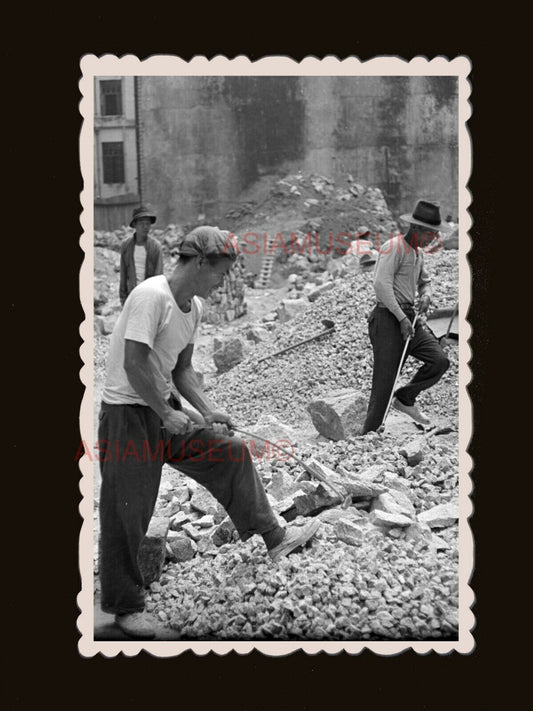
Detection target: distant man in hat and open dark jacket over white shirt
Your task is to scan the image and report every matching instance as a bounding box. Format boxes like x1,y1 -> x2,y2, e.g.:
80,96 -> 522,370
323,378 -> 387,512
119,205 -> 163,306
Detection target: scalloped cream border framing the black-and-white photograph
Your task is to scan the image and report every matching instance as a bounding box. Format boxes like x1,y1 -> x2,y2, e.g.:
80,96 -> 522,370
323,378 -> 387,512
77,54 -> 475,657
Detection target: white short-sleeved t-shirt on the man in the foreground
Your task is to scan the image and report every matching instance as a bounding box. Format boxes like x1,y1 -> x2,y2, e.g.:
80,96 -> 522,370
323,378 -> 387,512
102,274 -> 203,405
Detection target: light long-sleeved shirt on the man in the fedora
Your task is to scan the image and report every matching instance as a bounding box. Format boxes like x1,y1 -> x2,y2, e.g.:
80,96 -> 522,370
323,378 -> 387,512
374,235 -> 431,321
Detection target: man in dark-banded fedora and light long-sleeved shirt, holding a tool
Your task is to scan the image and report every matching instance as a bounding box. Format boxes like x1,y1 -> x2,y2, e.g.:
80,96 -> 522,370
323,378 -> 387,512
361,200 -> 449,434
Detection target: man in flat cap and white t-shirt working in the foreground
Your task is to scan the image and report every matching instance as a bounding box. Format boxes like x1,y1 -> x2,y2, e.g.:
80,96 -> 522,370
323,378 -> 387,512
98,227 -> 318,639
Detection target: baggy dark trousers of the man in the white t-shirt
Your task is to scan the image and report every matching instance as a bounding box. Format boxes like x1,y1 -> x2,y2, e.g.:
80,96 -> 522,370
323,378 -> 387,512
98,403 -> 278,614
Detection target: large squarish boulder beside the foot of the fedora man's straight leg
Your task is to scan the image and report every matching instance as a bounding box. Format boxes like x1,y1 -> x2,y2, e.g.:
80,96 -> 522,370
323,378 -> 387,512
307,388 -> 367,441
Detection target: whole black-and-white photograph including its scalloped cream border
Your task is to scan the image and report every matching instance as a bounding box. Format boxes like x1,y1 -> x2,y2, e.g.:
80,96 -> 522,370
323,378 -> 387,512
77,55 -> 475,657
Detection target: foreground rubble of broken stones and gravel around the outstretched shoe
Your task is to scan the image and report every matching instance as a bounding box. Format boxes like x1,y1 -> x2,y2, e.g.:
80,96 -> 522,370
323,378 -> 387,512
129,422 -> 458,639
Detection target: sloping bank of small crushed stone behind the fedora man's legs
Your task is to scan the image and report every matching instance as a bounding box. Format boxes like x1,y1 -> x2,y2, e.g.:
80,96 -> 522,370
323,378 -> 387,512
207,251 -> 458,426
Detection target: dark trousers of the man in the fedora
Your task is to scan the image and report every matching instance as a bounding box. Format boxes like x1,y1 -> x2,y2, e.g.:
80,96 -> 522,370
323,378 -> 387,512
363,307 -> 450,434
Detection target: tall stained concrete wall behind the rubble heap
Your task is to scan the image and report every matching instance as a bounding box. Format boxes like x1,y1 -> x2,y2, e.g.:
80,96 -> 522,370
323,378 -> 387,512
139,77 -> 458,224
